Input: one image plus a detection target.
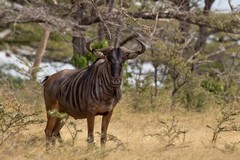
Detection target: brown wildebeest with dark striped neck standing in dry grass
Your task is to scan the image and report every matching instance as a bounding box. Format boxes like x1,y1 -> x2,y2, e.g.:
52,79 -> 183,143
43,38 -> 146,144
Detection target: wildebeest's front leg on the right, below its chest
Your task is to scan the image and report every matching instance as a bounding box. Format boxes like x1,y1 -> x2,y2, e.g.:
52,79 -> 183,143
101,111 -> 113,145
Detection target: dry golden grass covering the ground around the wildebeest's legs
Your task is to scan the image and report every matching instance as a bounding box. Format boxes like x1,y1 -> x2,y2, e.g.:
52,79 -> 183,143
0,84 -> 240,160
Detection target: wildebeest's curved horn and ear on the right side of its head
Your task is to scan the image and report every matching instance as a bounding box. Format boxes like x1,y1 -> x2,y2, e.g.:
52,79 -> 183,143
120,38 -> 146,59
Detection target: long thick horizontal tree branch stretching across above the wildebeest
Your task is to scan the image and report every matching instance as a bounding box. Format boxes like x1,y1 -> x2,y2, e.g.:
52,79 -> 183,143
0,3 -> 240,34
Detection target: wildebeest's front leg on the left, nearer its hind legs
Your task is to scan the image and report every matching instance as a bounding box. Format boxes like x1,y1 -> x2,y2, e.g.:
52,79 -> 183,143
87,111 -> 95,143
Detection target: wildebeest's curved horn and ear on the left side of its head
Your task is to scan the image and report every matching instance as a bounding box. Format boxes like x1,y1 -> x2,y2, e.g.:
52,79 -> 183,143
86,37 -> 113,58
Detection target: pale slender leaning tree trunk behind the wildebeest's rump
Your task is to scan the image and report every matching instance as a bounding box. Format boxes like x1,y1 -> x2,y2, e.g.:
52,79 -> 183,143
31,29 -> 50,81
